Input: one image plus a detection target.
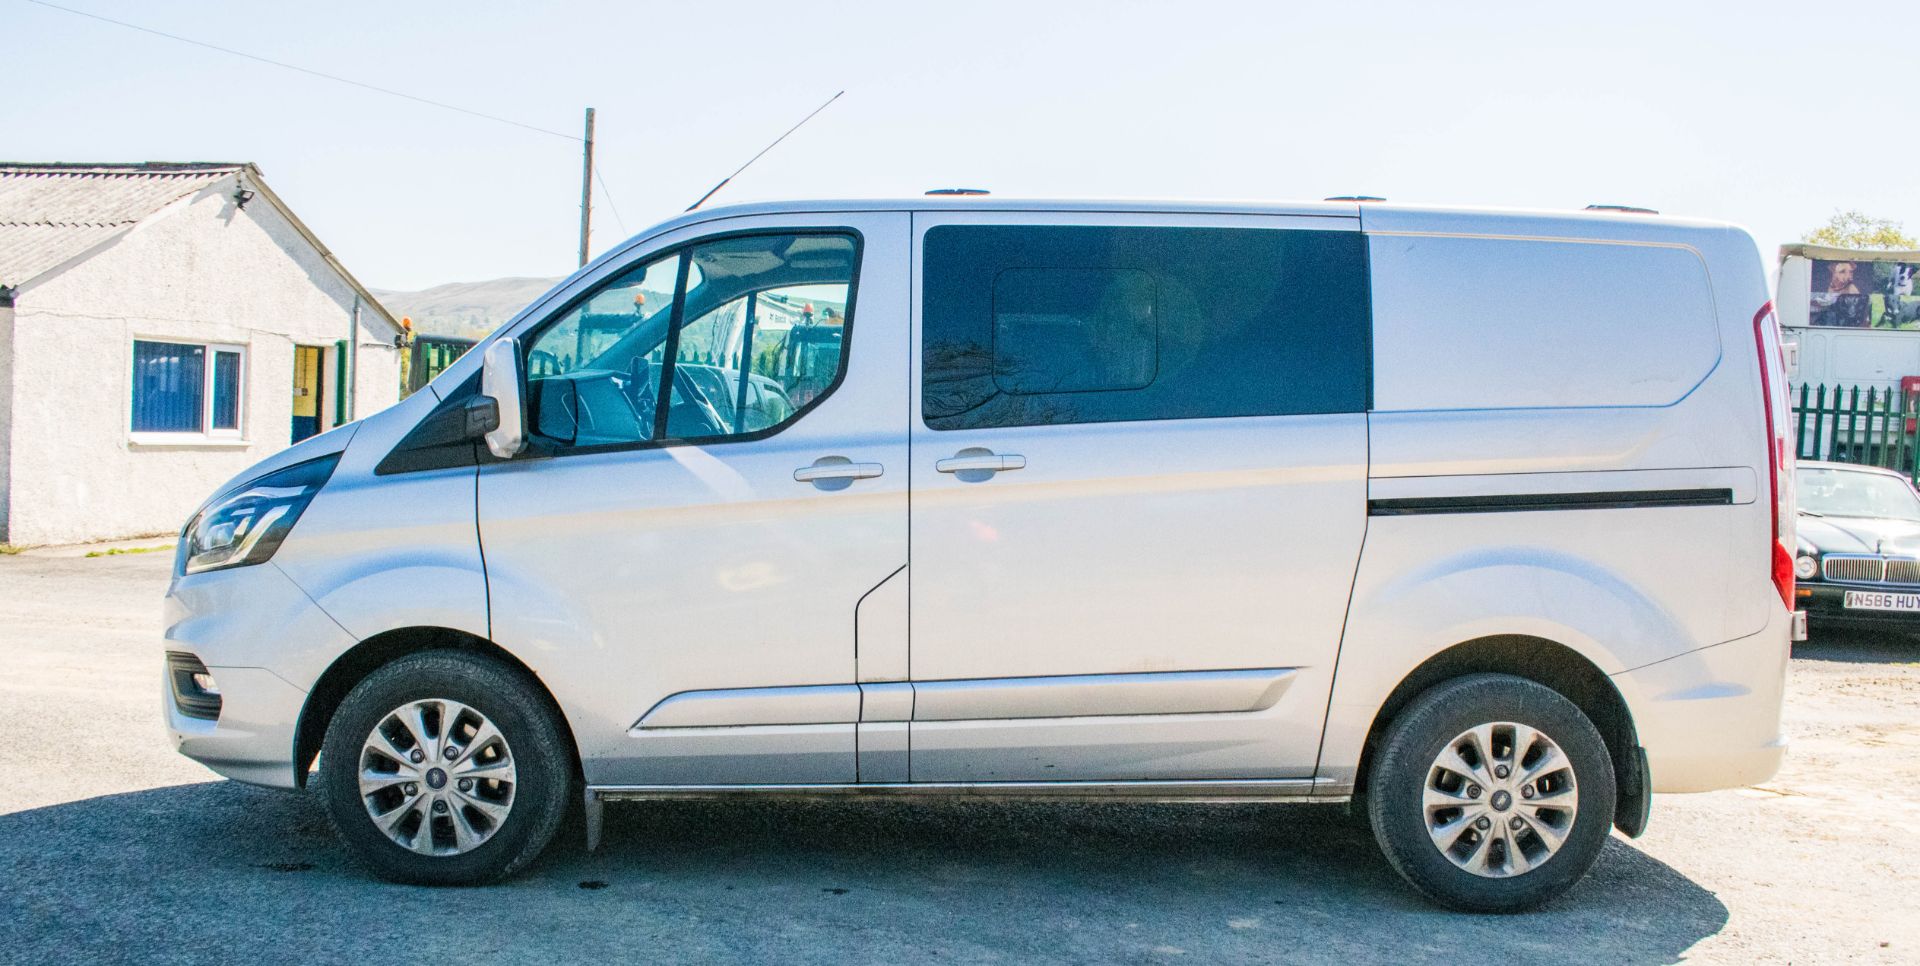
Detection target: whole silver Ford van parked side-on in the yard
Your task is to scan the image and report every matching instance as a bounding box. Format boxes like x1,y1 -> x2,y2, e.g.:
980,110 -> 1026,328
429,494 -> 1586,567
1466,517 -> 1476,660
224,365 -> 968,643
163,198 -> 1795,910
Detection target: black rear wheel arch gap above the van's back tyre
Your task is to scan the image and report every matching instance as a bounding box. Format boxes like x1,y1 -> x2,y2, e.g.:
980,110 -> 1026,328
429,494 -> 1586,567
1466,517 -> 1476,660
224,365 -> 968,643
1354,634 -> 1651,837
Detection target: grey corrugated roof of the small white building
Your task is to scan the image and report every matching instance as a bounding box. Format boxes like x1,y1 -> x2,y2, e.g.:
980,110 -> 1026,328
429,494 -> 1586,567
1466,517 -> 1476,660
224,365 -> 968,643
0,161 -> 246,286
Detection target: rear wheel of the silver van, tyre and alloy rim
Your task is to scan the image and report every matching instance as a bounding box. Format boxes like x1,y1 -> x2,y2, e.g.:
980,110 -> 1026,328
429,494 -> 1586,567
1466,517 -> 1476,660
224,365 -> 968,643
1367,674 -> 1615,912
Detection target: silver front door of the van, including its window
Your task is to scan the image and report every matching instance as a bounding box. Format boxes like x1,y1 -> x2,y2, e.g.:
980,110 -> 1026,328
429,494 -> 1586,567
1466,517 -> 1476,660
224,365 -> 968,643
478,213 -> 908,785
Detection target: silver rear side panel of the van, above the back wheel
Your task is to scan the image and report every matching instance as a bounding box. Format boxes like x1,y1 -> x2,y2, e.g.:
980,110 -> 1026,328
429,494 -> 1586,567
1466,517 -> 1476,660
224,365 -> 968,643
1319,209 -> 1786,795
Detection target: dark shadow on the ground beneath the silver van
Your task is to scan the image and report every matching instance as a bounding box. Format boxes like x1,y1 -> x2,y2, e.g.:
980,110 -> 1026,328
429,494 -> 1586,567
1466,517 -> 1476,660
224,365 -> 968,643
0,782 -> 1726,964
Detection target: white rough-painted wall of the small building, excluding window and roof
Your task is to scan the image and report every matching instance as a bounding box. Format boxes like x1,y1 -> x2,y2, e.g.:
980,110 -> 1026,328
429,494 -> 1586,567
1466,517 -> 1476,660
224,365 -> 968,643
0,179 -> 399,543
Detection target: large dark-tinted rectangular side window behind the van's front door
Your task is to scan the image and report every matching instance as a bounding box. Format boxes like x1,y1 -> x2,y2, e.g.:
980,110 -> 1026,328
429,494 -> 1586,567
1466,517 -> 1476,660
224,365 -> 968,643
922,225 -> 1369,430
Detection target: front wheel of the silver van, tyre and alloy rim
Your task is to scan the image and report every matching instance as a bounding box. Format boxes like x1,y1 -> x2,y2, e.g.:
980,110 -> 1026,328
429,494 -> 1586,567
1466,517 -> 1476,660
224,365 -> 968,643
321,651 -> 574,885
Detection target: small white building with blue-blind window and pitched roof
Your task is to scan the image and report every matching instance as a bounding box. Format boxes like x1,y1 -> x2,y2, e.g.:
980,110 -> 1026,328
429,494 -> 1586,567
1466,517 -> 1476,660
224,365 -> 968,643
0,163 -> 399,545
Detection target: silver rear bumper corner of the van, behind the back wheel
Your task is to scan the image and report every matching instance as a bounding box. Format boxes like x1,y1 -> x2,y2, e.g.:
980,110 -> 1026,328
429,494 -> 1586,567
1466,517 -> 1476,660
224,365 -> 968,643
1613,611 -> 1793,791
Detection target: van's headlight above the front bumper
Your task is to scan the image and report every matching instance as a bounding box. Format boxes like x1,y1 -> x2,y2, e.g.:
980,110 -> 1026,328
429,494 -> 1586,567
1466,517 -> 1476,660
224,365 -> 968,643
179,453 -> 340,574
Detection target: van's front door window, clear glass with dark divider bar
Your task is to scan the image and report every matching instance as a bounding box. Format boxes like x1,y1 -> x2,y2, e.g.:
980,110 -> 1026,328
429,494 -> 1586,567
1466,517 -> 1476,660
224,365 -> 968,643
526,234 -> 856,447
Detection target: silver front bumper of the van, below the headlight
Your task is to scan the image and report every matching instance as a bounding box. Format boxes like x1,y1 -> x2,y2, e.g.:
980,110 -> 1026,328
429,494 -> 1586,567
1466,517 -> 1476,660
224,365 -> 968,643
161,563 -> 353,787
